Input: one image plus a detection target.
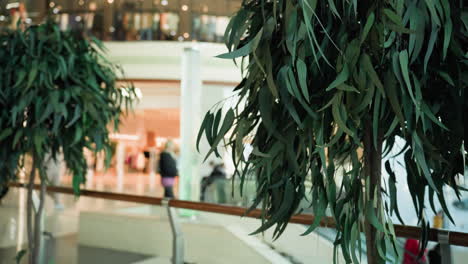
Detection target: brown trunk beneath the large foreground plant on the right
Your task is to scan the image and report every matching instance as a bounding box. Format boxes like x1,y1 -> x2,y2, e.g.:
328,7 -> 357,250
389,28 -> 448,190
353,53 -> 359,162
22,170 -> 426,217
364,120 -> 385,264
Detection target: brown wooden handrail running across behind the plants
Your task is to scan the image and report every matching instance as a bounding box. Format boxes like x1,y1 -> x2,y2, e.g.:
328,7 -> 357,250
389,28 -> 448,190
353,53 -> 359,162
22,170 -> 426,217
10,183 -> 468,247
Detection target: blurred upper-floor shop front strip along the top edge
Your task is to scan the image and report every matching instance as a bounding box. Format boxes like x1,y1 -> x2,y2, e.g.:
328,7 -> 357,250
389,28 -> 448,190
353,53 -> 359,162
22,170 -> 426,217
0,0 -> 241,42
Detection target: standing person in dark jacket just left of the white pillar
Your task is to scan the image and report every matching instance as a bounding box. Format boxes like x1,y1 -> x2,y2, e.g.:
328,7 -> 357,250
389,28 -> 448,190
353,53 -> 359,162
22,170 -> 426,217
159,141 -> 179,198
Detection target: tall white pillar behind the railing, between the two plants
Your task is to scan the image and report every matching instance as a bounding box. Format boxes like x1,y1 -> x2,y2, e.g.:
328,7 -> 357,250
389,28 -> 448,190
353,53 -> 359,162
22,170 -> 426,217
179,47 -> 202,200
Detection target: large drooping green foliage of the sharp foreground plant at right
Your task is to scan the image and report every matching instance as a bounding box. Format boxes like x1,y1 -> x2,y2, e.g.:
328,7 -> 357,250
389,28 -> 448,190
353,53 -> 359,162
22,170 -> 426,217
199,0 -> 468,264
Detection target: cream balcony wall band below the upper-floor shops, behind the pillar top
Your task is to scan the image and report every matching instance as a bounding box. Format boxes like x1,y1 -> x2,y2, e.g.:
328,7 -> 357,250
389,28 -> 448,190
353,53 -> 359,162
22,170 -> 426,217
105,41 -> 242,84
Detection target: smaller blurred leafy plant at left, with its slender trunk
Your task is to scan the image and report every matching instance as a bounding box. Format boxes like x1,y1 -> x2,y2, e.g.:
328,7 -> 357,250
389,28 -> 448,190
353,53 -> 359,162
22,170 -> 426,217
0,21 -> 135,263
